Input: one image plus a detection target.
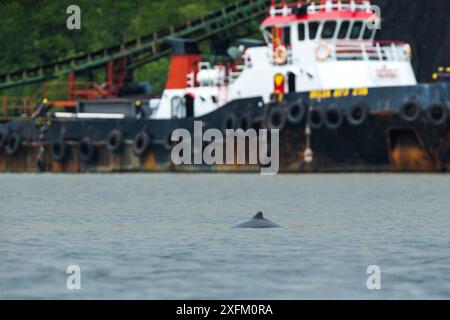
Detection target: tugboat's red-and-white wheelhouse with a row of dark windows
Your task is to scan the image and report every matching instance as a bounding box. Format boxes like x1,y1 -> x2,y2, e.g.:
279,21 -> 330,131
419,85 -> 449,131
261,0 -> 411,65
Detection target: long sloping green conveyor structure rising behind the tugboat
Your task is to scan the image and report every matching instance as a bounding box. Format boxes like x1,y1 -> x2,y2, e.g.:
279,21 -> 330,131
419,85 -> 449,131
0,0 -> 269,90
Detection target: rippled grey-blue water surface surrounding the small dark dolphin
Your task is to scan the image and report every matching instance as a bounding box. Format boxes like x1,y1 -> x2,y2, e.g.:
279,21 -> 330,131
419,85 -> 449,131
0,174 -> 450,299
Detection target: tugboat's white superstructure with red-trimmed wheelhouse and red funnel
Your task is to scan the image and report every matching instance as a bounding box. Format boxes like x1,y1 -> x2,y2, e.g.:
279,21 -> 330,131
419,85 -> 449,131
151,0 -> 417,119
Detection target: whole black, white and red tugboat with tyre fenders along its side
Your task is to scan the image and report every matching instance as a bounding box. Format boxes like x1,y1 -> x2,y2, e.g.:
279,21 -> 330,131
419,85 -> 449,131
0,0 -> 450,172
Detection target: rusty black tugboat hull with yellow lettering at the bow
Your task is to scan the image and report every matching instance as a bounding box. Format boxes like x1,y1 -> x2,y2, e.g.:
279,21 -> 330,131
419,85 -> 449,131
0,83 -> 450,172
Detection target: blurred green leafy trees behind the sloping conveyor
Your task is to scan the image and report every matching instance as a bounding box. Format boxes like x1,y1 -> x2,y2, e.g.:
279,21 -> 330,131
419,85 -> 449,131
0,0 -> 229,91
